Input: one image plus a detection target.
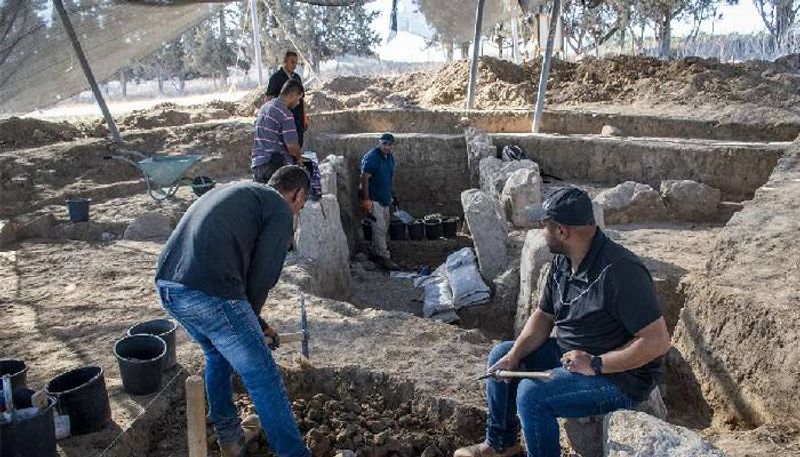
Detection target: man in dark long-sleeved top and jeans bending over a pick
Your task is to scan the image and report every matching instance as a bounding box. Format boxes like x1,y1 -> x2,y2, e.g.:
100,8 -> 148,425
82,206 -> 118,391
156,165 -> 311,457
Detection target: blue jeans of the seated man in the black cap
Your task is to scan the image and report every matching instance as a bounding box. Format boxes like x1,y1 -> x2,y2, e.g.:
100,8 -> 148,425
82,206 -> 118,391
486,338 -> 636,457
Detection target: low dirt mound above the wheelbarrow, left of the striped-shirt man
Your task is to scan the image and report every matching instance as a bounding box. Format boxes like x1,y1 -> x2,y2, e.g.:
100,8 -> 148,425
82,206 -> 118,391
119,102 -> 231,130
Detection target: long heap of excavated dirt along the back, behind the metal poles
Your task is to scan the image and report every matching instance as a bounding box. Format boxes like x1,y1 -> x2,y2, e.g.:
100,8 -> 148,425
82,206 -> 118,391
288,56 -> 800,110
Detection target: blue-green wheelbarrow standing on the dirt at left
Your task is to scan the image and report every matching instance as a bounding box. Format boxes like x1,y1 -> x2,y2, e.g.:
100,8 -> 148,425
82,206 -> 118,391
103,149 -> 216,201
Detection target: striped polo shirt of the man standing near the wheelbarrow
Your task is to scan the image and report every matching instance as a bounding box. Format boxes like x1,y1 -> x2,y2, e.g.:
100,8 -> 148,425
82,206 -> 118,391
250,97 -> 298,167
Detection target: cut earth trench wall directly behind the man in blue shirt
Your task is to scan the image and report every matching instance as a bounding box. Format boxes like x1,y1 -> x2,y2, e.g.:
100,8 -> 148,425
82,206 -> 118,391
306,133 -> 470,224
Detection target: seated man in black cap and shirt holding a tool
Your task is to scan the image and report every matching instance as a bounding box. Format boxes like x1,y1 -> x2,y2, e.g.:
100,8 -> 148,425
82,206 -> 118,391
454,187 -> 670,457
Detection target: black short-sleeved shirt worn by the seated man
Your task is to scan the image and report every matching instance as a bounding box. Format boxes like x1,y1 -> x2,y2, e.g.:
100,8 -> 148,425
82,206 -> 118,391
539,229 -> 663,401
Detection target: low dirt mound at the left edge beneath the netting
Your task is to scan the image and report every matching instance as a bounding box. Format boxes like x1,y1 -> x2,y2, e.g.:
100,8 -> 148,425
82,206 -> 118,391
0,117 -> 83,148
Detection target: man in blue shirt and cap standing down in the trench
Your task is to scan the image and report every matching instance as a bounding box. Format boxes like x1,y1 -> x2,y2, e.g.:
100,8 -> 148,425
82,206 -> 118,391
360,133 -> 397,270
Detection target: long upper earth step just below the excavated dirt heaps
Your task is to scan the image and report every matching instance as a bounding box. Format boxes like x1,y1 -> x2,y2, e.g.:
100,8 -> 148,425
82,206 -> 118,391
311,109 -> 800,141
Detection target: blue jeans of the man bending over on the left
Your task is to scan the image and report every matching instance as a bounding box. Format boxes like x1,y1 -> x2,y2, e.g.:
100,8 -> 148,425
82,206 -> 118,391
157,281 -> 311,457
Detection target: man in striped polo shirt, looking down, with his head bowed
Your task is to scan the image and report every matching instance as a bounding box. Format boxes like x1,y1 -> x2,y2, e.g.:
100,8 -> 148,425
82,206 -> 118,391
250,79 -> 303,184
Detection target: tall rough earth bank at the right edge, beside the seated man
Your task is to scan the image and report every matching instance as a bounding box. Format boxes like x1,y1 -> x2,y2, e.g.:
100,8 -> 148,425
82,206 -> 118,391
671,141 -> 800,427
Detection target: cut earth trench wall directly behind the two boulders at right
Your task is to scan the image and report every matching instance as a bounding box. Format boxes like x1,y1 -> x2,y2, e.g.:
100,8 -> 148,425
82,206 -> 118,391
492,134 -> 788,201
